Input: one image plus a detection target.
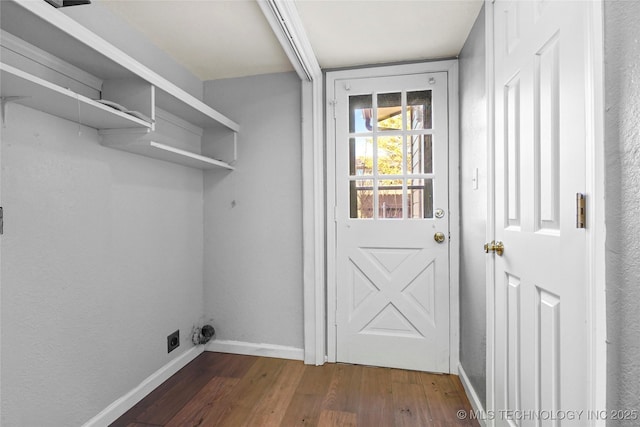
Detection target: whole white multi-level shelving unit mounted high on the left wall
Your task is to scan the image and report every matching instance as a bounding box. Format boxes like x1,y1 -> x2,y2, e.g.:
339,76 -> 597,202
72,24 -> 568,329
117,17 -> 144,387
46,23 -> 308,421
0,0 -> 240,170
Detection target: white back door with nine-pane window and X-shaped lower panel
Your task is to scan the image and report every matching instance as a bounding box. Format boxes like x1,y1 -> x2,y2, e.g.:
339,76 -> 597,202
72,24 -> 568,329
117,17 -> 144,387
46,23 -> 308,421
334,73 -> 450,372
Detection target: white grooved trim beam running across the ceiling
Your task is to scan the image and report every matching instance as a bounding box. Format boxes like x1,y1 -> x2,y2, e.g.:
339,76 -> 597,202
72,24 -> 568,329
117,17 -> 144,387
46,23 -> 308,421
258,0 -> 322,82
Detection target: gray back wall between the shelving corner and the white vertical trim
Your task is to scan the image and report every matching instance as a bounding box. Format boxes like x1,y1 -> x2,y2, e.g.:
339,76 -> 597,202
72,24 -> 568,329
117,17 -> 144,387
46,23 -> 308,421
204,73 -> 303,349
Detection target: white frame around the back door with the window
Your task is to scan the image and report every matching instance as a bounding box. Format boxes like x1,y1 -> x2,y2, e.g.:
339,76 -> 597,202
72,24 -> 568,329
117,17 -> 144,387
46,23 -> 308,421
325,59 -> 460,374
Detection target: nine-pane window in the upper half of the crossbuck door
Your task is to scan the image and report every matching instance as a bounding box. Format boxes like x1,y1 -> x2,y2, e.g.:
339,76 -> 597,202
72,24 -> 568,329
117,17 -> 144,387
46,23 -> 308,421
349,90 -> 434,219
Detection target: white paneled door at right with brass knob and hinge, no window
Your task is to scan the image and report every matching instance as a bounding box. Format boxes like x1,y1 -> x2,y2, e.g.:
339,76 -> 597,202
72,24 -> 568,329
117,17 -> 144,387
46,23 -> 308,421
493,0 -> 590,426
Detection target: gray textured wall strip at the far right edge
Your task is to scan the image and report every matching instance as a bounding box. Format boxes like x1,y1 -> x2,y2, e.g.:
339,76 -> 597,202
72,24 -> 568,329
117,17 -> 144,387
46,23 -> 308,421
604,1 -> 640,426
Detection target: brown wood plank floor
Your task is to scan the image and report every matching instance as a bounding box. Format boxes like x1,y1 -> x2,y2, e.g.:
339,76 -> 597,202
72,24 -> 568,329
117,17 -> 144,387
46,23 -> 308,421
111,352 -> 478,427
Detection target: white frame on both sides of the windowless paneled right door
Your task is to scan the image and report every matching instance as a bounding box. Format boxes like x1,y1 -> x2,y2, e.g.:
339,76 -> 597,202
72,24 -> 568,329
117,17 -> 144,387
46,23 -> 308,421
485,0 -> 607,426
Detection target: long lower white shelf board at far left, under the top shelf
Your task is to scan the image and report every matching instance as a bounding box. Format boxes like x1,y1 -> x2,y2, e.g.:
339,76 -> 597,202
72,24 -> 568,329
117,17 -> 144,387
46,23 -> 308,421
0,63 -> 151,129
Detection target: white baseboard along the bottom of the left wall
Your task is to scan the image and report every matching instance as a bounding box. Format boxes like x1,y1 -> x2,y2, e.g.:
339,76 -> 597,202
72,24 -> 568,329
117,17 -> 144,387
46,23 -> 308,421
82,345 -> 204,427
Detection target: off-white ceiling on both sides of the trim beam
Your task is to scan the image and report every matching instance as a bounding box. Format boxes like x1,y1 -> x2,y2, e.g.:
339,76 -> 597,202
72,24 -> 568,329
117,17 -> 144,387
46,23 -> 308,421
94,0 -> 483,80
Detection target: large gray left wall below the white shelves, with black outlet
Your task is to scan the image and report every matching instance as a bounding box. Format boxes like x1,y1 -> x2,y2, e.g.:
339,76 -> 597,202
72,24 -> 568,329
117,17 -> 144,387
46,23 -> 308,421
0,104 -> 203,427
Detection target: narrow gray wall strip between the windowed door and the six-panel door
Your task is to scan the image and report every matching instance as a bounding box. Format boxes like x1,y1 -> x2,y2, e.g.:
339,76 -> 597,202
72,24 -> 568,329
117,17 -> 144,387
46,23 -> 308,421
459,6 -> 487,405
